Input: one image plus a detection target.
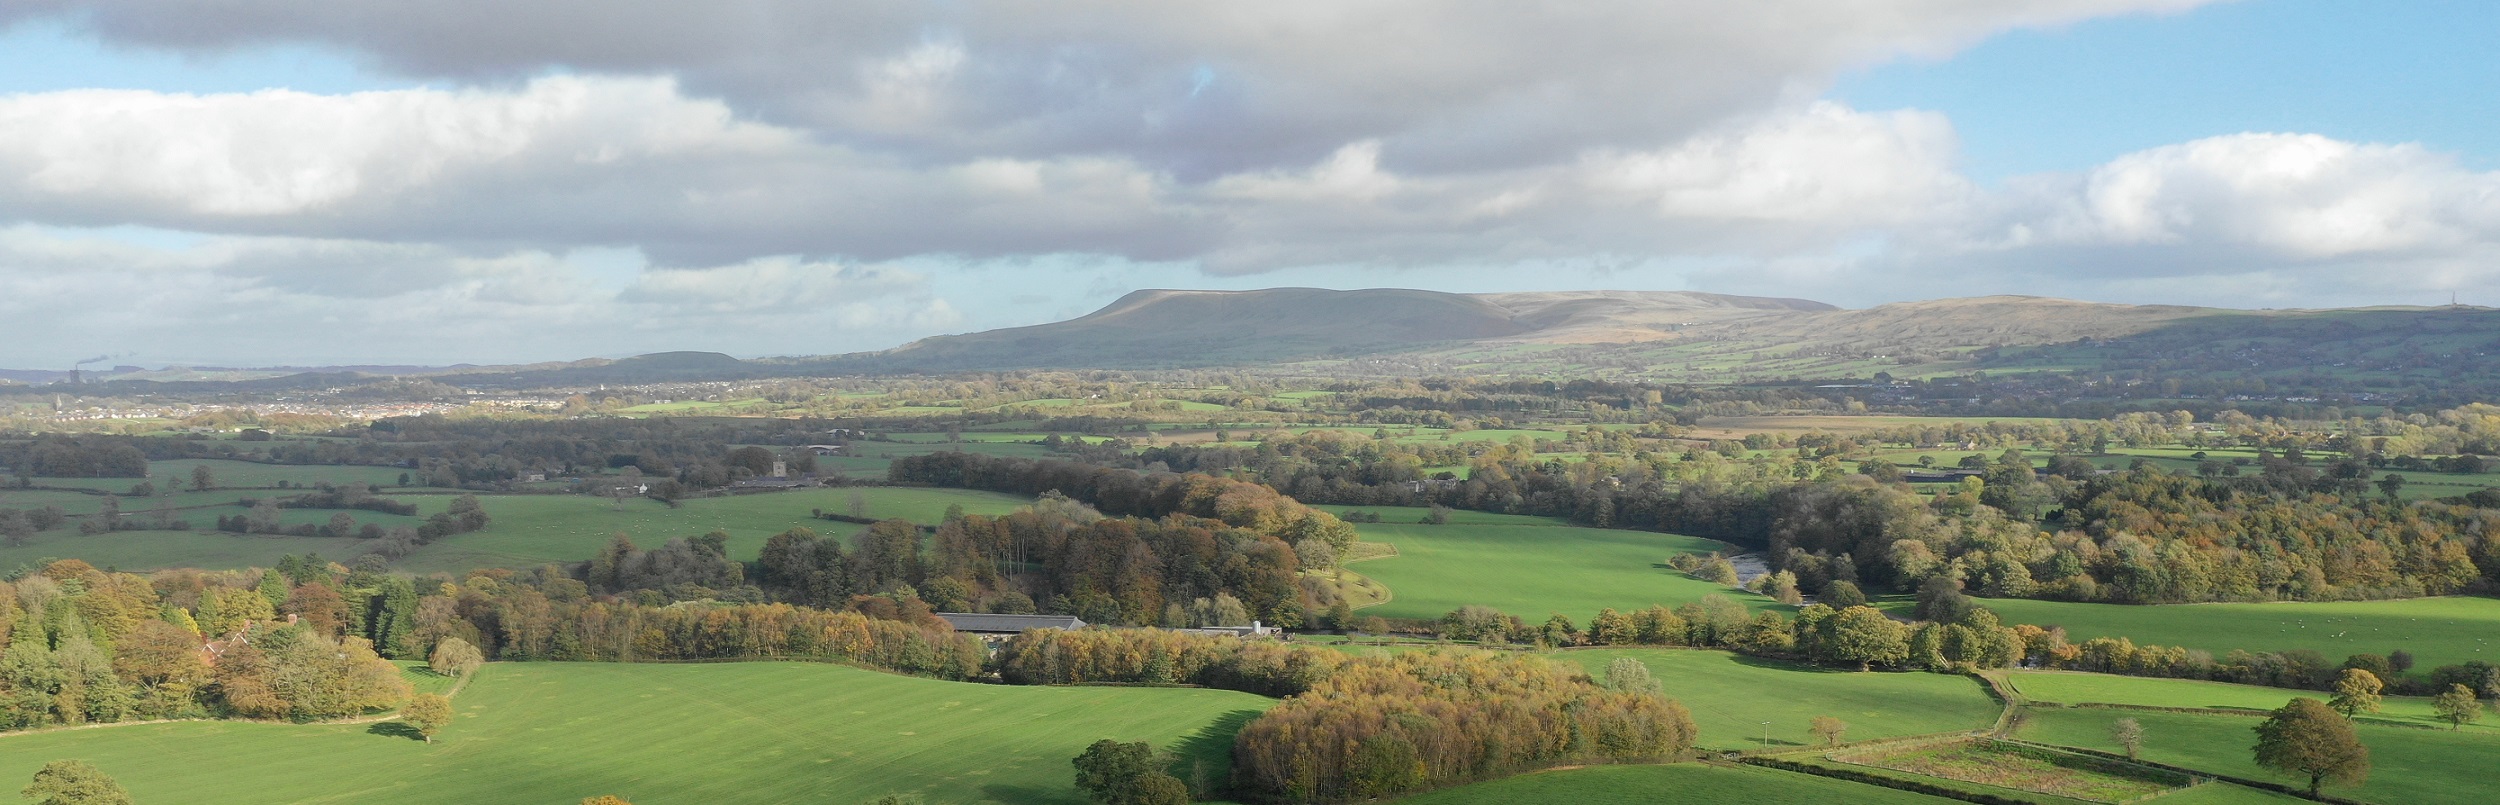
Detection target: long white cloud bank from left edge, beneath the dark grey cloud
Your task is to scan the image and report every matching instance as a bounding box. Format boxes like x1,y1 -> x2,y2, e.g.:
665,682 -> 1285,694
0,78 -> 1963,267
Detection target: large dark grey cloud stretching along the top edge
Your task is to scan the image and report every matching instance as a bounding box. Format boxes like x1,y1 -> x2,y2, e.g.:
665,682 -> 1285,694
0,0 -> 2208,180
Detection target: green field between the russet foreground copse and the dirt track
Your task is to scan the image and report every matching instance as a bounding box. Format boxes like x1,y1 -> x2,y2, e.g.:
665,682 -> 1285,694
1558,648 -> 2000,750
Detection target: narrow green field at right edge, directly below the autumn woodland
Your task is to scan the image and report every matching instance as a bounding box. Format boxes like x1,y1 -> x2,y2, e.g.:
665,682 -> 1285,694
1920,595 -> 2500,670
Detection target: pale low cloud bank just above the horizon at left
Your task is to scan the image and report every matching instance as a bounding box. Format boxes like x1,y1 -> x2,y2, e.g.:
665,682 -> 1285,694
0,225 -> 960,365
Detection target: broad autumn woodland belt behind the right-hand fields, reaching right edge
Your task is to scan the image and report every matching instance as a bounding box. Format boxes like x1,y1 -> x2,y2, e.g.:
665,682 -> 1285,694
1113,433 -> 2500,603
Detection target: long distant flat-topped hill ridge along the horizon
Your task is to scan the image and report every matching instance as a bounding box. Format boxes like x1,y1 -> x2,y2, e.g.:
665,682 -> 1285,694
0,288 -> 2500,388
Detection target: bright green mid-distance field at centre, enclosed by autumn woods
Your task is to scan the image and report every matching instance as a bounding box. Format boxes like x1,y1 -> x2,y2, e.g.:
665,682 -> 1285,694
1353,508 -> 1778,625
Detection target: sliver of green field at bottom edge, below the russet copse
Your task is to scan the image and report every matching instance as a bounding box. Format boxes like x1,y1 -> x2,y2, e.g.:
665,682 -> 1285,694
1398,763 -> 1960,805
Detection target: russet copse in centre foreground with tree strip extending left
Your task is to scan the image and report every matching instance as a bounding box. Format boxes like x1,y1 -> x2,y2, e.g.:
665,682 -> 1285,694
998,630 -> 1695,803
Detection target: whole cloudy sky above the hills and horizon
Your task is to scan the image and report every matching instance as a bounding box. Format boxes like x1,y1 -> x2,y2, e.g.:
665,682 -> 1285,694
0,0 -> 2500,368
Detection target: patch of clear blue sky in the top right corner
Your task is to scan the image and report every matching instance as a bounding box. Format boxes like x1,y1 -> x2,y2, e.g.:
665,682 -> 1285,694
1830,0 -> 2500,183
